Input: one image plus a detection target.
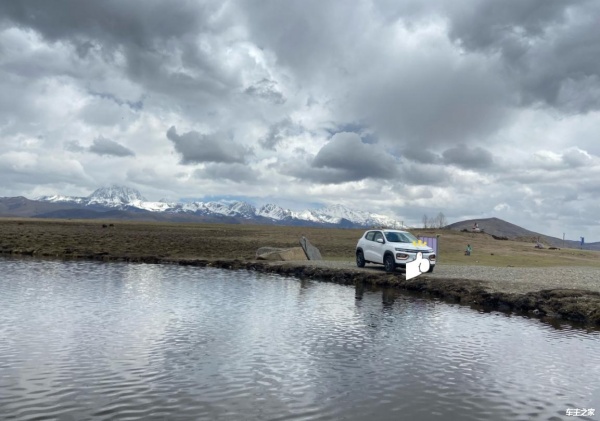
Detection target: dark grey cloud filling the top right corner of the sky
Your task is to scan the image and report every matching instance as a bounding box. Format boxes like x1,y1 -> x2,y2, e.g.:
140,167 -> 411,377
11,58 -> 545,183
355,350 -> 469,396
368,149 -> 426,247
448,0 -> 600,113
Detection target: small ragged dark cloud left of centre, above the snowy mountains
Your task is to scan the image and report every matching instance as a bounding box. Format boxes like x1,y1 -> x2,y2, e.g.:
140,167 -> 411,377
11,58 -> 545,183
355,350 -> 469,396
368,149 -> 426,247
167,127 -> 251,164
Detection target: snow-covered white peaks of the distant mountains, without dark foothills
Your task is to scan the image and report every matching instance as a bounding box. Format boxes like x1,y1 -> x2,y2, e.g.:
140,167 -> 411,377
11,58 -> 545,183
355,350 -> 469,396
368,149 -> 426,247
36,185 -> 402,228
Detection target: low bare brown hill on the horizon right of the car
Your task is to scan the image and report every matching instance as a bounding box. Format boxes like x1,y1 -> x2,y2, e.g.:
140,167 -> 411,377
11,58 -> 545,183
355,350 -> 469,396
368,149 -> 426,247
446,218 -> 600,250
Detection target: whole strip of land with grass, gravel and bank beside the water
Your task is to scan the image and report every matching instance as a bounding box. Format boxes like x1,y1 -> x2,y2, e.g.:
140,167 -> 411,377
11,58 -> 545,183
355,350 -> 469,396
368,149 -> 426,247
0,218 -> 600,328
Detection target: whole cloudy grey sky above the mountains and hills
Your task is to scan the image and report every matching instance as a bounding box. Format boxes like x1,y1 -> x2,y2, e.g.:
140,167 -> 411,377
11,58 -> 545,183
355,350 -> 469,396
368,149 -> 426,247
0,0 -> 600,241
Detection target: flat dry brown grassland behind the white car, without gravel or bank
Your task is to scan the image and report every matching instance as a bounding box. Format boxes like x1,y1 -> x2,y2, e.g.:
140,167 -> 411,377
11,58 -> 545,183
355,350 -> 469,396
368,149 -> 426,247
0,218 -> 600,267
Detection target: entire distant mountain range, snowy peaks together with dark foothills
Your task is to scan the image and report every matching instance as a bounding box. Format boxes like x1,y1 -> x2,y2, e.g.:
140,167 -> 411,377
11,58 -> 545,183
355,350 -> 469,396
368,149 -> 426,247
0,185 -> 406,228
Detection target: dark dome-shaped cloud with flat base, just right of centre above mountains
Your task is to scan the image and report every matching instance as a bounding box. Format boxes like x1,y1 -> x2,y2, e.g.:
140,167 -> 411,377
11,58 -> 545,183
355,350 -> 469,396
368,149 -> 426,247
285,133 -> 398,184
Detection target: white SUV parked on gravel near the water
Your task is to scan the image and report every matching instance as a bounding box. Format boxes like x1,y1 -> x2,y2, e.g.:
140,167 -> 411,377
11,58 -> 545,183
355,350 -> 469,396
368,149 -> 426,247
356,230 -> 435,272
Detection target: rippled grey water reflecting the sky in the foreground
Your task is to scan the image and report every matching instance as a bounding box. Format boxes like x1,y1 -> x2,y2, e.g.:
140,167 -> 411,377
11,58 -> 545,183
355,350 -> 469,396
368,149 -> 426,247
0,259 -> 600,421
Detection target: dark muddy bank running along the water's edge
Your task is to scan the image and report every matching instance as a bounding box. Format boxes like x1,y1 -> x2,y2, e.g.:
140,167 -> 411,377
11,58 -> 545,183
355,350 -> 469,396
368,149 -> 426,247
5,251 -> 600,327
